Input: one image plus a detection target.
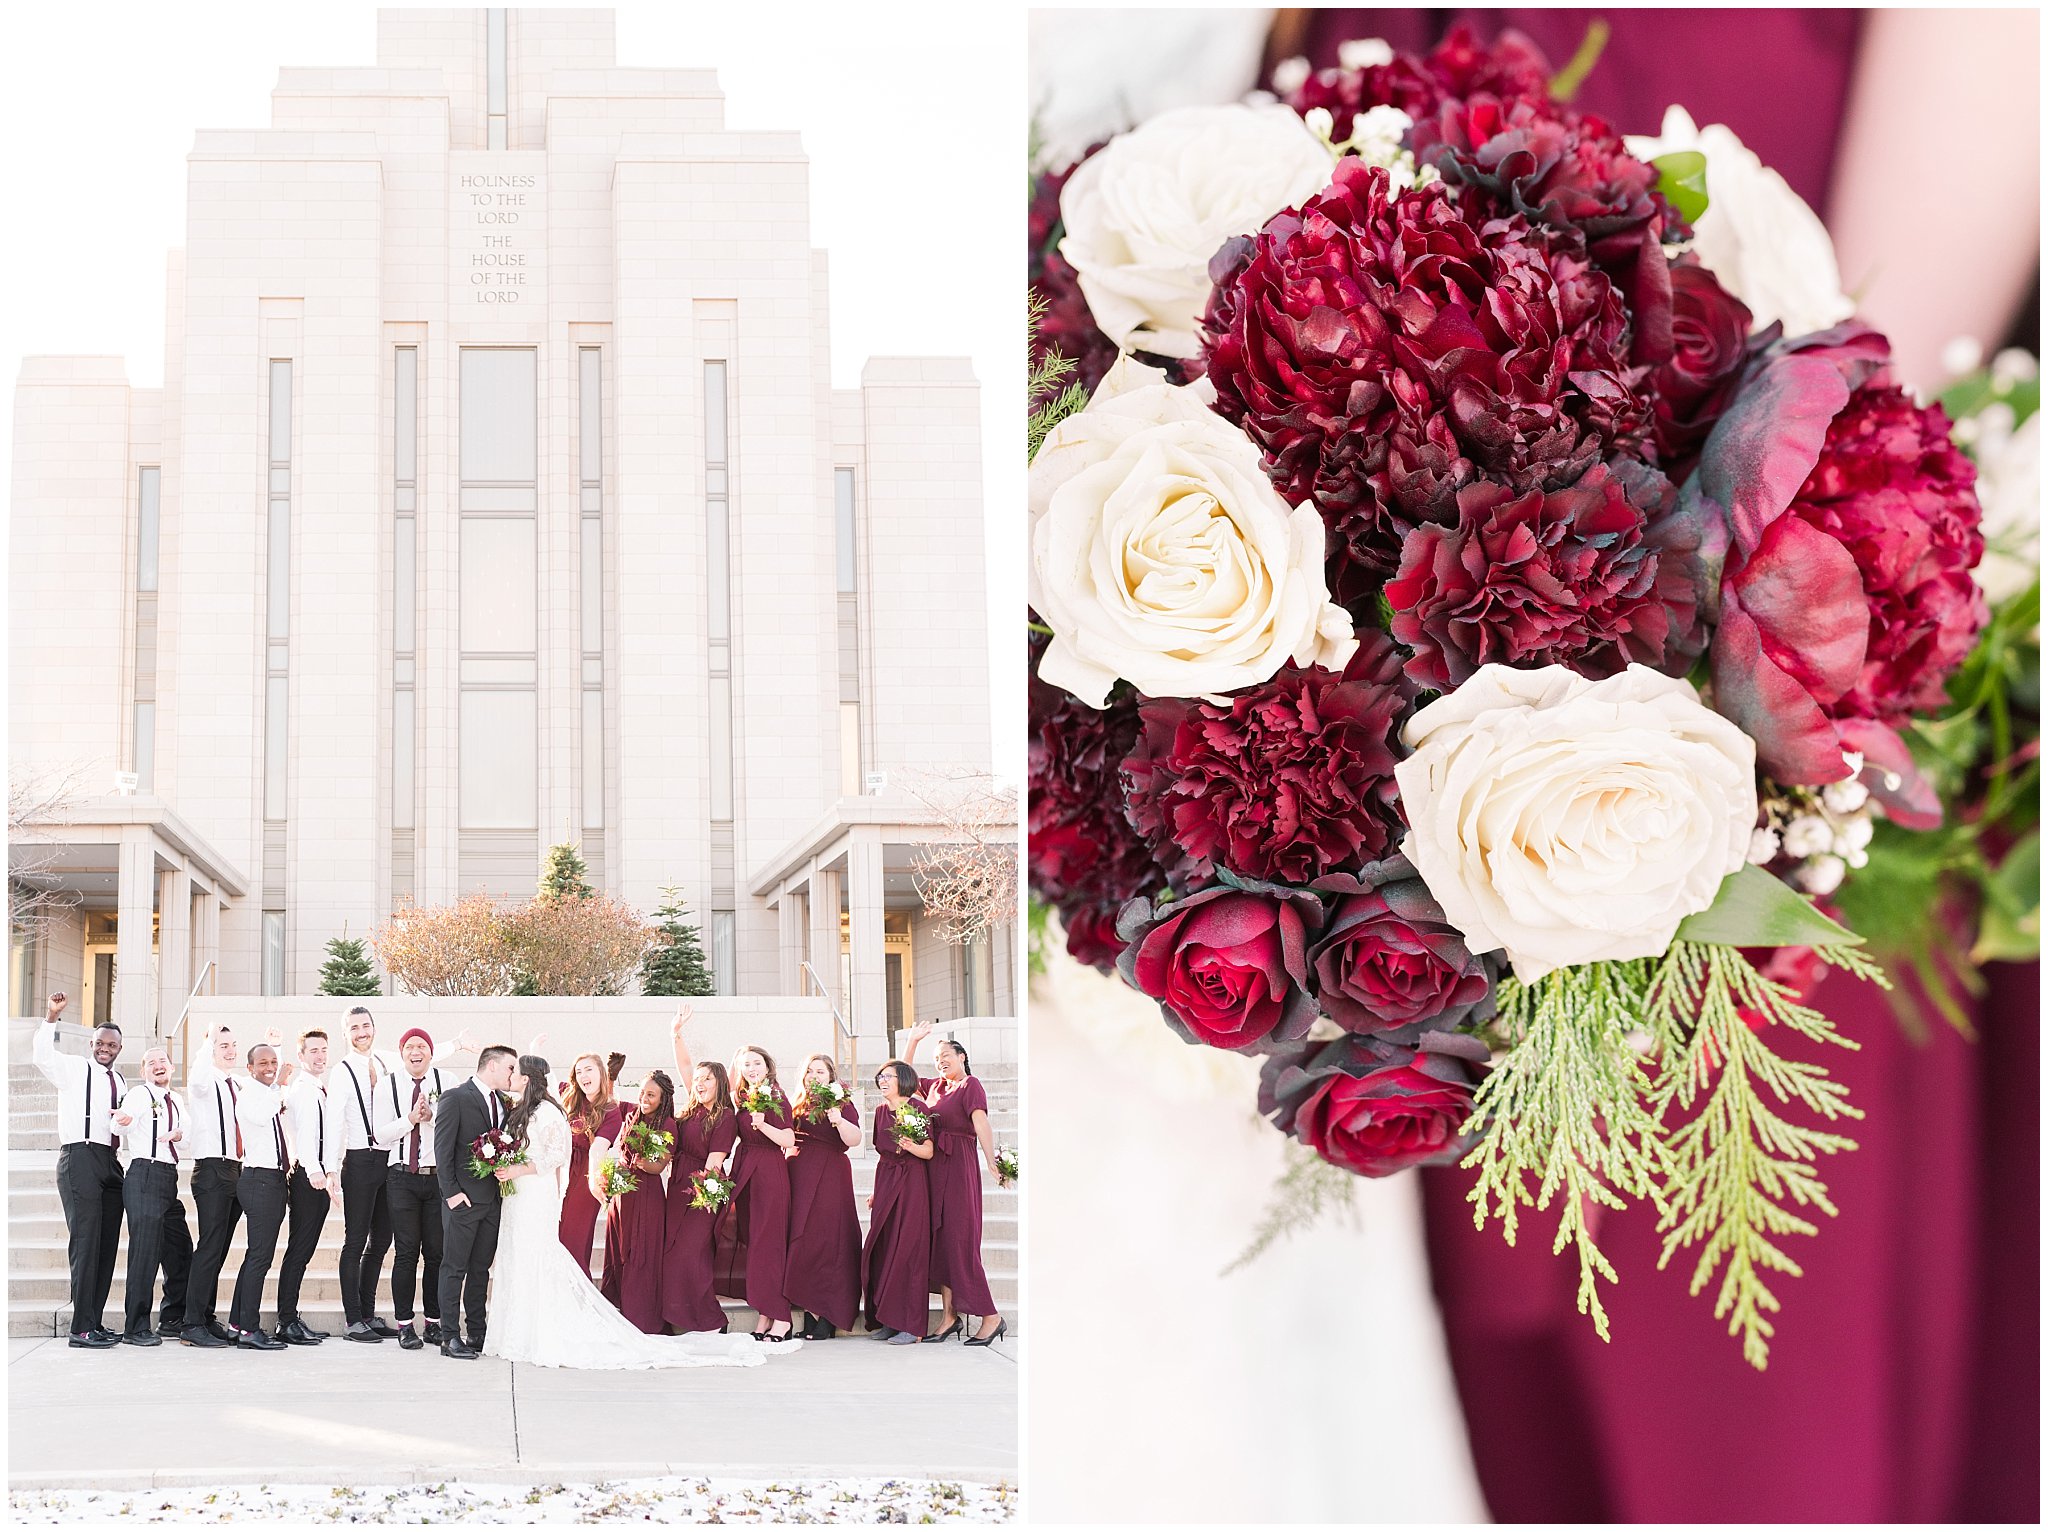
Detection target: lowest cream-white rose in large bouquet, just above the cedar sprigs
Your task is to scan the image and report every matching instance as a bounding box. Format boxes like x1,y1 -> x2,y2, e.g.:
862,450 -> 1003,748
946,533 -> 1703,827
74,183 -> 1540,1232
1395,666 -> 1757,983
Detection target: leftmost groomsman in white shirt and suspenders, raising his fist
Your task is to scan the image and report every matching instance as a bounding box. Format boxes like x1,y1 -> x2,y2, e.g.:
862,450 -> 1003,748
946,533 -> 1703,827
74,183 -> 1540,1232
29,993 -> 127,1352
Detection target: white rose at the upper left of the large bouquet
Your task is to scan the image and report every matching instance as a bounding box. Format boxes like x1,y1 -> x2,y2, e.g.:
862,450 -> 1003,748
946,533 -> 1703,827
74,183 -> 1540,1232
1059,104 -> 1335,356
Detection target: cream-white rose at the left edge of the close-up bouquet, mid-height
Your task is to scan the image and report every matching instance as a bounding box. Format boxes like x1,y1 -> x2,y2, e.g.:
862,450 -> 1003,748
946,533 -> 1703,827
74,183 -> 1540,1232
1030,356 -> 1358,707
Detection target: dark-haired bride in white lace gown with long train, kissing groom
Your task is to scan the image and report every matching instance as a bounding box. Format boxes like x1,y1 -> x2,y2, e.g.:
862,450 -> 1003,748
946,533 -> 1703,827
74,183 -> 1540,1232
483,1053 -> 801,1368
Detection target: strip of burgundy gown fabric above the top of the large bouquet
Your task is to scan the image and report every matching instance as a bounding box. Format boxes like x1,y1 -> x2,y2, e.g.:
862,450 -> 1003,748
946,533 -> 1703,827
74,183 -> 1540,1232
1303,8 -> 1864,217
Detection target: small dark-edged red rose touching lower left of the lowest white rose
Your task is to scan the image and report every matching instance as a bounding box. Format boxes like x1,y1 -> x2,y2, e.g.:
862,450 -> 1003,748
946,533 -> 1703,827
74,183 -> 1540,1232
1309,856 -> 1499,1032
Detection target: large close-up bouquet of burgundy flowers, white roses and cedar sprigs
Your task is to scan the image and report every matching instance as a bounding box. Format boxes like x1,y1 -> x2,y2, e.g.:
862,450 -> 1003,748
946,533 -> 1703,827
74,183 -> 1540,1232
1030,29 -> 1987,1368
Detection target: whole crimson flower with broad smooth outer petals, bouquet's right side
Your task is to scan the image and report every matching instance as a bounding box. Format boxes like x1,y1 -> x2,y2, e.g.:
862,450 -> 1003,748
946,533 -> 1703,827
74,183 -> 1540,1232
1712,324 -> 1987,829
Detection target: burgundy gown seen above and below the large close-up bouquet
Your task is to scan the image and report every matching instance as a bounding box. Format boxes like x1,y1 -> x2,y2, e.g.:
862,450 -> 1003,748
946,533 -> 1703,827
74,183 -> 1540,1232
1288,20 -> 2040,1524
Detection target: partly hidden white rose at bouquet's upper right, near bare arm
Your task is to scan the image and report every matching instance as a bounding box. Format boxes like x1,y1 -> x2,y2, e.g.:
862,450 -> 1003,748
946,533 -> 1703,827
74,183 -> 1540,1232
1628,107 -> 1855,336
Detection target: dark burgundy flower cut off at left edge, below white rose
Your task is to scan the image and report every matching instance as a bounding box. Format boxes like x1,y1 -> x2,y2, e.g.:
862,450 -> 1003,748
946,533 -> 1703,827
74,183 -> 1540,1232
1028,635 -> 1165,969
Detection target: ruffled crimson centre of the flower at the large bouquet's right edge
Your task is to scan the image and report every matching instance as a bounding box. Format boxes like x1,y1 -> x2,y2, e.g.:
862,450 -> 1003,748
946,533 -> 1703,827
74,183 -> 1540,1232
1792,383 -> 1989,725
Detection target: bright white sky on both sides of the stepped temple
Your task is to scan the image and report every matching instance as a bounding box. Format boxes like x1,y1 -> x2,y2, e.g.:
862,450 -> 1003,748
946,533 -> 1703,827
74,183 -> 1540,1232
0,0 -> 1024,780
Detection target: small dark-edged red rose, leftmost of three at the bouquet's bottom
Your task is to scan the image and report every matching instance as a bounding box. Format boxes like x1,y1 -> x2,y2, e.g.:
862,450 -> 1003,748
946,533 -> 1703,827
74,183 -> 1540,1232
1116,885 -> 1319,1053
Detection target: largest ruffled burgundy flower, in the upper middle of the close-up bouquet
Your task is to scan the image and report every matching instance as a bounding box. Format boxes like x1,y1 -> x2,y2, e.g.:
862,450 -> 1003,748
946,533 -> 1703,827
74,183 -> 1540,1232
1202,160 -> 1649,604
